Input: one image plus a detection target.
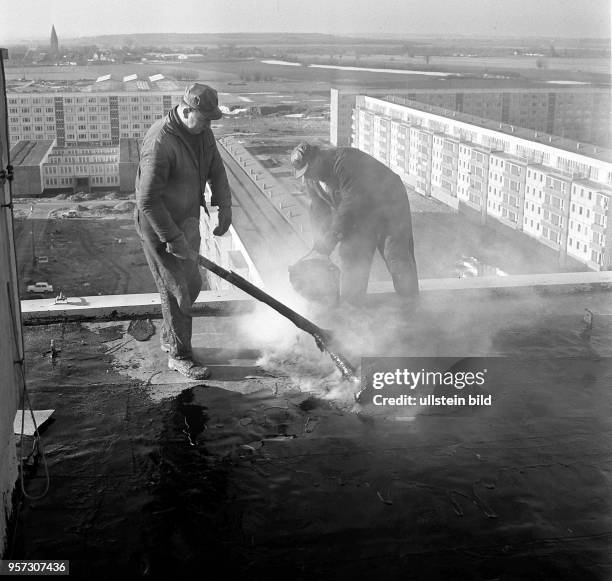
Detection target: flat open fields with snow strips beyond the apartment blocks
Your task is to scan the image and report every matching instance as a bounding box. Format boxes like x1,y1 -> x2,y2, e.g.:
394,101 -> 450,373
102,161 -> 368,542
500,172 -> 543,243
6,55 -> 610,92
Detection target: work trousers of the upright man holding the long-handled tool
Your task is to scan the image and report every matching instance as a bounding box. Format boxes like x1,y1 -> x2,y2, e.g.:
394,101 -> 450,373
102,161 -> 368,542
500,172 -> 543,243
141,216 -> 202,359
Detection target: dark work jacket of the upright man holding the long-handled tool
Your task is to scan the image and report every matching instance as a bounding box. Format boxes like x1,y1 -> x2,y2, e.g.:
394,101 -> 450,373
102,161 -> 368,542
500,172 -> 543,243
136,109 -> 231,245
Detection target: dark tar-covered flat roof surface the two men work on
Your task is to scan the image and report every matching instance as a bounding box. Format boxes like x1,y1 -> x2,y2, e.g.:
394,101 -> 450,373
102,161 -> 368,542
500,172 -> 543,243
5,292 -> 612,580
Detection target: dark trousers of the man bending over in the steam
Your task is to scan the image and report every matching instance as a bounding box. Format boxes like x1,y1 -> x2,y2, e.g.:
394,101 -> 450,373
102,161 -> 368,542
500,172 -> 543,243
338,214 -> 419,304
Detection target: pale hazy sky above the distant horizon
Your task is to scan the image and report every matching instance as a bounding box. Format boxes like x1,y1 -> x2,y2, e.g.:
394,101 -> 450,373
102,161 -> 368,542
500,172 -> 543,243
0,0 -> 611,43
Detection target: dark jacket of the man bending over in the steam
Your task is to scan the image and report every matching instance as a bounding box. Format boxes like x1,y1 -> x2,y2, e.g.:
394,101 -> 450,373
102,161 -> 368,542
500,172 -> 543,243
306,147 -> 412,245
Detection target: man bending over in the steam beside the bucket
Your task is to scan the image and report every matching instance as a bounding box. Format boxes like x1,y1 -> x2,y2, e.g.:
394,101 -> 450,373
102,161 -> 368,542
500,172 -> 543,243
291,142 -> 419,303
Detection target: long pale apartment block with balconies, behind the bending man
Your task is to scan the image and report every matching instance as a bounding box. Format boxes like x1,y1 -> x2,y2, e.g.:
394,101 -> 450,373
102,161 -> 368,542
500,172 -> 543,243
353,96 -> 612,270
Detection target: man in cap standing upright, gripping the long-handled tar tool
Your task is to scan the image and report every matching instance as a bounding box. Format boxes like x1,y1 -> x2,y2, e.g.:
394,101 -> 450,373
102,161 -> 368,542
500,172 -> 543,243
135,83 -> 232,379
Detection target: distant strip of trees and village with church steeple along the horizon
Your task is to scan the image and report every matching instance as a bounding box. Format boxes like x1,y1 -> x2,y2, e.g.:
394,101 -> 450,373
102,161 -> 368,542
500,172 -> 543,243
6,26 -> 612,68
